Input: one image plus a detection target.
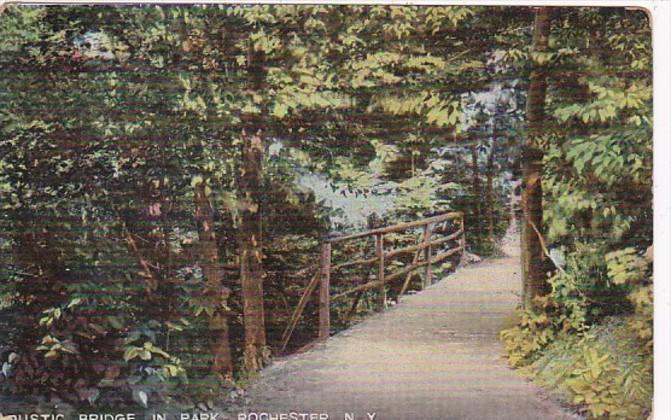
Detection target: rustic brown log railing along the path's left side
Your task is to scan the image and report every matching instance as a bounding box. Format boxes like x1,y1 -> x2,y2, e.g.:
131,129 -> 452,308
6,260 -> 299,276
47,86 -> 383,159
282,212 -> 466,351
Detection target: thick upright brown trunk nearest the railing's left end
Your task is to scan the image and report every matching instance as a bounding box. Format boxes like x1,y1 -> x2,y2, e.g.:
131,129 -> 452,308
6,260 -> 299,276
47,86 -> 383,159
239,44 -> 266,372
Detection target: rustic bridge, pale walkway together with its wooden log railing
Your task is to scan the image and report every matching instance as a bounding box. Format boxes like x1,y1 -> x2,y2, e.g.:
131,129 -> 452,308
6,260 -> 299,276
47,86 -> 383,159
234,221 -> 580,420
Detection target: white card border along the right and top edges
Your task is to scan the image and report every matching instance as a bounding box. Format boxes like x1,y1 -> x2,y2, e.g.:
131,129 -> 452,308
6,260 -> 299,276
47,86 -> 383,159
0,0 -> 671,420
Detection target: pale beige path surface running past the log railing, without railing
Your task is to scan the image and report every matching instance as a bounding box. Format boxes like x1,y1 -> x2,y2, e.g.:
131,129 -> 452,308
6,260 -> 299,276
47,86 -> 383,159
231,230 -> 578,420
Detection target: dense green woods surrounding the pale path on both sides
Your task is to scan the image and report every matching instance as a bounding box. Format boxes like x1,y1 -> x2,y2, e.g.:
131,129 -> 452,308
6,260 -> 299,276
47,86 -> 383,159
0,5 -> 652,418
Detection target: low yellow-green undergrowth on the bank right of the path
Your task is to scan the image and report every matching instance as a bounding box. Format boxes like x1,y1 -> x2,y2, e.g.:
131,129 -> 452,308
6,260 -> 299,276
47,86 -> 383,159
501,244 -> 653,419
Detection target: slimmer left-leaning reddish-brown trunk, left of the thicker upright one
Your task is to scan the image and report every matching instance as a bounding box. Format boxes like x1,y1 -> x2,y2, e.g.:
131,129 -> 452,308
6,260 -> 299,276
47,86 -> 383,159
195,182 -> 233,382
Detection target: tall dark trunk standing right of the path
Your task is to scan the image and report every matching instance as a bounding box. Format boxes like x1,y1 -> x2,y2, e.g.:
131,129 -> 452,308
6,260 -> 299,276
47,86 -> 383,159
522,7 -> 551,307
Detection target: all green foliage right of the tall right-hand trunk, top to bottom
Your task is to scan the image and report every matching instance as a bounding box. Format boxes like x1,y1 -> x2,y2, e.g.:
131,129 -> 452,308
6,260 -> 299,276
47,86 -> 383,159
501,9 -> 652,418
